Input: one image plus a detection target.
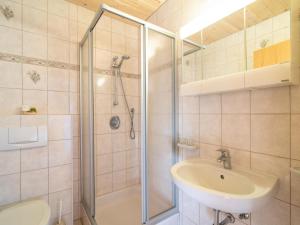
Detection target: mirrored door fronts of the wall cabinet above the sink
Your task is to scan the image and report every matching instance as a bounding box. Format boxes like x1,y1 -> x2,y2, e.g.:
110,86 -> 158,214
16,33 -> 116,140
182,0 -> 291,84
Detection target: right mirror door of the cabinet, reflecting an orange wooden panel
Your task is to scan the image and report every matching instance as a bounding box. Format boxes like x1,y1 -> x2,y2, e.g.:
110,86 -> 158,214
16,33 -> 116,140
246,0 -> 291,70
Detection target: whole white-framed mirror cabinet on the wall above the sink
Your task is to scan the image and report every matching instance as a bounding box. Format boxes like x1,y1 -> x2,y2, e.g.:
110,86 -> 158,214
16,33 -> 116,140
180,0 -> 300,95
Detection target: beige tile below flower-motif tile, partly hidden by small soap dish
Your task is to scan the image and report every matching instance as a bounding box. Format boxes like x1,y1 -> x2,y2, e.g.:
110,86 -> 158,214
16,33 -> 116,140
23,90 -> 47,114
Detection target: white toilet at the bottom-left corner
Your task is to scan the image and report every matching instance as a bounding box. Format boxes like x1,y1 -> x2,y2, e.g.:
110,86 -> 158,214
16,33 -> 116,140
0,200 -> 50,225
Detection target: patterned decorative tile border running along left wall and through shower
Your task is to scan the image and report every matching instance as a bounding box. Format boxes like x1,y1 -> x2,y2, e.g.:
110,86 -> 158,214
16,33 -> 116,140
0,52 -> 140,79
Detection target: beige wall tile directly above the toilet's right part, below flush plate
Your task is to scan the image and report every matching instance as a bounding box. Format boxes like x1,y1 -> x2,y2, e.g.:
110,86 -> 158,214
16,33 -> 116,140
21,169 -> 48,200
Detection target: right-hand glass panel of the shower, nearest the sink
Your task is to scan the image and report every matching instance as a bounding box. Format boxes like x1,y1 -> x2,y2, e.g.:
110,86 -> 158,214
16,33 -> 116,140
146,27 -> 175,218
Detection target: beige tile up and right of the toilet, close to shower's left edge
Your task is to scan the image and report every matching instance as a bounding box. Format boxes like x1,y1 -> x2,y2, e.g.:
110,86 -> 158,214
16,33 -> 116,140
49,164 -> 73,193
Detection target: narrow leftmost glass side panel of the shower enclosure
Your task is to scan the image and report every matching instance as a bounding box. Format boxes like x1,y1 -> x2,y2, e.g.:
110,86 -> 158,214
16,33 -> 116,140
80,31 -> 94,215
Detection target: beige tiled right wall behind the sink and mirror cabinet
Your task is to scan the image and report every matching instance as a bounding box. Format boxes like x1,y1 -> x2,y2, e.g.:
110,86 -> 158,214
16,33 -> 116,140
150,0 -> 300,225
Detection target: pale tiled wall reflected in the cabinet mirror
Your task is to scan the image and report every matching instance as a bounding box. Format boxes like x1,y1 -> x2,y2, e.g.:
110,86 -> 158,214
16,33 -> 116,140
182,11 -> 290,83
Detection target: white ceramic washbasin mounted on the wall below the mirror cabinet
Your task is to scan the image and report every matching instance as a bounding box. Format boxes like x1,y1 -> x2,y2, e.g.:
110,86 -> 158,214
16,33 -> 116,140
171,159 -> 278,213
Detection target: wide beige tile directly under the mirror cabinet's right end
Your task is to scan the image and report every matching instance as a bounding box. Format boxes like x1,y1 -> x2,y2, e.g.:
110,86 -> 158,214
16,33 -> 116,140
251,87 -> 290,113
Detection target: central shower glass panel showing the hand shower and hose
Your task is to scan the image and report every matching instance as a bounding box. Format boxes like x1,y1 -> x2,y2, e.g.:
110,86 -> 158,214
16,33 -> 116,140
93,12 -> 142,225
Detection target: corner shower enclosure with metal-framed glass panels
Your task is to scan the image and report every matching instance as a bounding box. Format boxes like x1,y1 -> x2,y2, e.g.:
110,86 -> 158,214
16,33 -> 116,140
80,5 -> 178,225
